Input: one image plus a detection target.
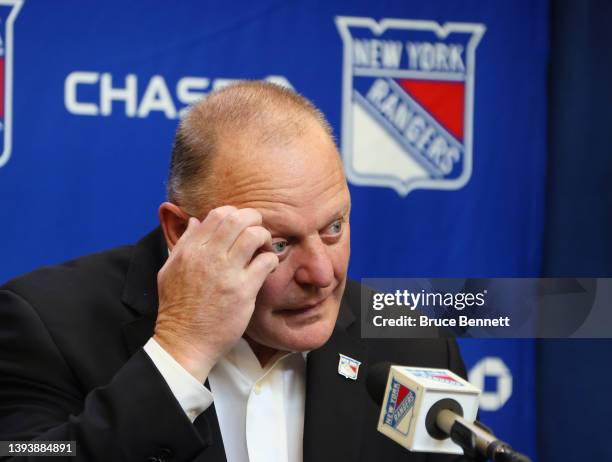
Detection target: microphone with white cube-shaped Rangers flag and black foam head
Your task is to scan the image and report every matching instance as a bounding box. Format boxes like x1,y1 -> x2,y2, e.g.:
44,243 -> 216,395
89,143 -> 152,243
366,362 -> 530,462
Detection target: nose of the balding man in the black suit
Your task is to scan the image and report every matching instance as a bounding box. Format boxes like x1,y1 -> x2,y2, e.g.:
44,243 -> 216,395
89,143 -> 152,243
295,235 -> 334,287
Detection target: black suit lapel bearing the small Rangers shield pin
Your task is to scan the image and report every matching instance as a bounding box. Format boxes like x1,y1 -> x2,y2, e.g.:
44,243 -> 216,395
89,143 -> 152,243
304,303 -> 369,462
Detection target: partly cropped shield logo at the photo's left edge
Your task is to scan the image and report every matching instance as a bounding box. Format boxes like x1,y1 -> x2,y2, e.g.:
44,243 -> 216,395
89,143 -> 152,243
0,0 -> 23,167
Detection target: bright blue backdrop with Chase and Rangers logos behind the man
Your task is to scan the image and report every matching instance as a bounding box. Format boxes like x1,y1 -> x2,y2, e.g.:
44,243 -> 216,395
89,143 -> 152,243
0,0 -> 549,458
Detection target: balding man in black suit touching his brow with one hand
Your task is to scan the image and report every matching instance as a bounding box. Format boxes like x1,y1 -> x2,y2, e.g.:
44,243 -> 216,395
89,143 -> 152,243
0,82 -> 465,462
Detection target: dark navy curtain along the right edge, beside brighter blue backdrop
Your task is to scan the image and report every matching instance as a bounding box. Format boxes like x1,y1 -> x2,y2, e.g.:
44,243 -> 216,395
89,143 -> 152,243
536,0 -> 612,461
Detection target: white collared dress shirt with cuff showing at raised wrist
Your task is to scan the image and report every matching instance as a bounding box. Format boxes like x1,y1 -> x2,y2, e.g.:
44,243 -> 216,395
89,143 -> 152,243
144,338 -> 306,462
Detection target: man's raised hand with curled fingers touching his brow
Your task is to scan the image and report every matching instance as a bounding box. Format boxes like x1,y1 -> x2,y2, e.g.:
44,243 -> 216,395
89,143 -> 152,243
154,206 -> 278,382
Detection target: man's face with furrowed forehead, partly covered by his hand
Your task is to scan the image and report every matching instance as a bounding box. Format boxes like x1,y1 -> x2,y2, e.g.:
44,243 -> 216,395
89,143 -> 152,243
213,122 -> 350,351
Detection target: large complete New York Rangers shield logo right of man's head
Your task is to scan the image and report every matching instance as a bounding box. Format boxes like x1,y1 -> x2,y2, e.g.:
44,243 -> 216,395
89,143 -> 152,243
336,16 -> 485,196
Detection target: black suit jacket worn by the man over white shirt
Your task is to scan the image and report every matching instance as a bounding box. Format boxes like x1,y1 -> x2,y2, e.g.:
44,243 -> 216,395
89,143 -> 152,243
0,229 -> 465,462
